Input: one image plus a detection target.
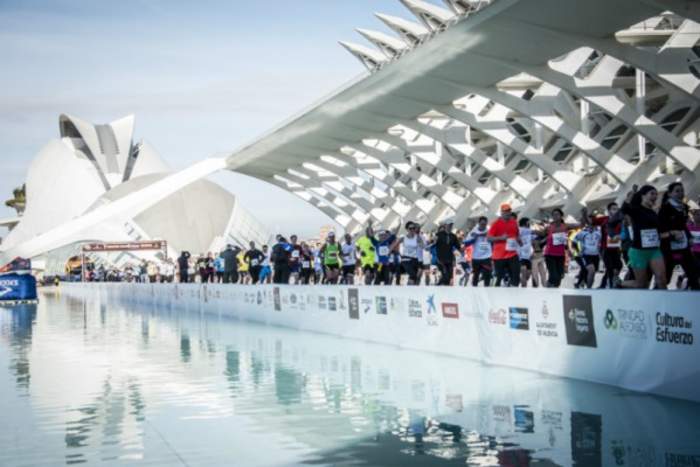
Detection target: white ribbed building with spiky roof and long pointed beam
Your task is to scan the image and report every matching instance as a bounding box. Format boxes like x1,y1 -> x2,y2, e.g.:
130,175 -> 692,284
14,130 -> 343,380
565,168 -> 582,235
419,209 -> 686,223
3,0 -> 700,259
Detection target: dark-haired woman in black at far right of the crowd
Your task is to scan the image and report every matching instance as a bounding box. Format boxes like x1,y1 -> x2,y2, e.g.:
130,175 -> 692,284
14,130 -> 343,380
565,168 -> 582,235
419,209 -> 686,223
659,182 -> 700,290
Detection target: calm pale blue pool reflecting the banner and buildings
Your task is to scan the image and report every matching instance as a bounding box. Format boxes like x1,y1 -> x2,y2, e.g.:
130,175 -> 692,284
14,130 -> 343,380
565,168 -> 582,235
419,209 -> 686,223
0,295 -> 700,467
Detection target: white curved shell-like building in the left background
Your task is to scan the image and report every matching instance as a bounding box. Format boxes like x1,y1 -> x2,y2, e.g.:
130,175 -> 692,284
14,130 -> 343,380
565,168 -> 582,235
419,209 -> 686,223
0,115 -> 270,269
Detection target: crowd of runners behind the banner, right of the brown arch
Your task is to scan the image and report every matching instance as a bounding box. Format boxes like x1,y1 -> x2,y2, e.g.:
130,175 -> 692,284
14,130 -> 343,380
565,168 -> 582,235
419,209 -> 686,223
171,183 -> 700,290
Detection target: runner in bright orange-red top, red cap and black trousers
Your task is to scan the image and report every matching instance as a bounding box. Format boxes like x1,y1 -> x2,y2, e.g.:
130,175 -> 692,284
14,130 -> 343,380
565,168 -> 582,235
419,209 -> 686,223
487,203 -> 521,287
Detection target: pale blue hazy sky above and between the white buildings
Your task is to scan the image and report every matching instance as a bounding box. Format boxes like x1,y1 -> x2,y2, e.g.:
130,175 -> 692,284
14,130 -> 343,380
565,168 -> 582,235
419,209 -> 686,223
0,0 -> 411,236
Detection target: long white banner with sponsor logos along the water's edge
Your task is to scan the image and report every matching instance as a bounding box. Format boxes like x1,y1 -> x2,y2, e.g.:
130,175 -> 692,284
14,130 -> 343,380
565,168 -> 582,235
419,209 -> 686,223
62,284 -> 700,401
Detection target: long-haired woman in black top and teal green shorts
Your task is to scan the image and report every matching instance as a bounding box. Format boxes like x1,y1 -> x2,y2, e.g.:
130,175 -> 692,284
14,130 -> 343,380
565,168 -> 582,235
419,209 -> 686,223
622,185 -> 667,289
